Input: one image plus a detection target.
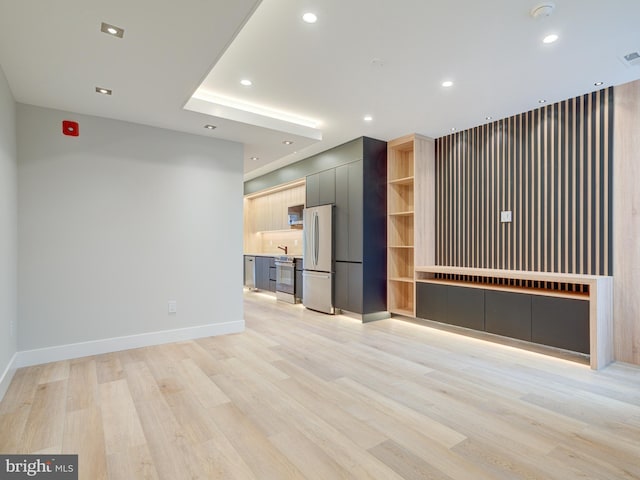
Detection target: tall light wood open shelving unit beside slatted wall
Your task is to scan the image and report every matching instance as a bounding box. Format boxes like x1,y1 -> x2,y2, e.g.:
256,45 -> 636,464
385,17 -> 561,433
387,134 -> 434,317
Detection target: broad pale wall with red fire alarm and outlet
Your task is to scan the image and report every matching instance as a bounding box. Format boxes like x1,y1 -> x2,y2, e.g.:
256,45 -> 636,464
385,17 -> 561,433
17,104 -> 244,356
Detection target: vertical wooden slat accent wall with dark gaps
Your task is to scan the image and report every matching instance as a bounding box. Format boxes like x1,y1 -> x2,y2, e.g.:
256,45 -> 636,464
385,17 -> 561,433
436,88 -> 613,275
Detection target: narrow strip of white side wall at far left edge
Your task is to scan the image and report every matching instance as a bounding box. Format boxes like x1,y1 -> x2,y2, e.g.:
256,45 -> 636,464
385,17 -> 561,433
0,67 -> 18,392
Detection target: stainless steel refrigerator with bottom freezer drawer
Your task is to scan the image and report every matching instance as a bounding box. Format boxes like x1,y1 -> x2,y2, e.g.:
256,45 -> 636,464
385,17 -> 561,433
302,205 -> 334,314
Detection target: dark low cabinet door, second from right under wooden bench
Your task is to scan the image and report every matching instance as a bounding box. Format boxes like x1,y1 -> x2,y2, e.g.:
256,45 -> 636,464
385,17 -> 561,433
484,290 -> 531,341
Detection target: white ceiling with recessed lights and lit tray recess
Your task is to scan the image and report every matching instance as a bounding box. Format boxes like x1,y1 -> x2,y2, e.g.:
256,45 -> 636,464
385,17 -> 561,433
0,0 -> 640,179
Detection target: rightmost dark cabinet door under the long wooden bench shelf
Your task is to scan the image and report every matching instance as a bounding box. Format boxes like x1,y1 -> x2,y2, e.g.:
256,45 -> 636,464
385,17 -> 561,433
531,295 -> 589,354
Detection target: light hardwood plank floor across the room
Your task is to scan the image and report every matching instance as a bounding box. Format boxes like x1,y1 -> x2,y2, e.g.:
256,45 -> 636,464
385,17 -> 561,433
0,293 -> 640,480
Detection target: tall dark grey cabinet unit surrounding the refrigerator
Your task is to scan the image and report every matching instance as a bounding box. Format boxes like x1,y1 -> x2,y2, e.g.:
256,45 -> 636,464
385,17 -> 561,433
306,137 -> 389,321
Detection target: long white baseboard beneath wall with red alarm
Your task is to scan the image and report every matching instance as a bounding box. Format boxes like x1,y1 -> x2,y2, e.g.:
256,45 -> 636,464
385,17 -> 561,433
15,320 -> 244,370
